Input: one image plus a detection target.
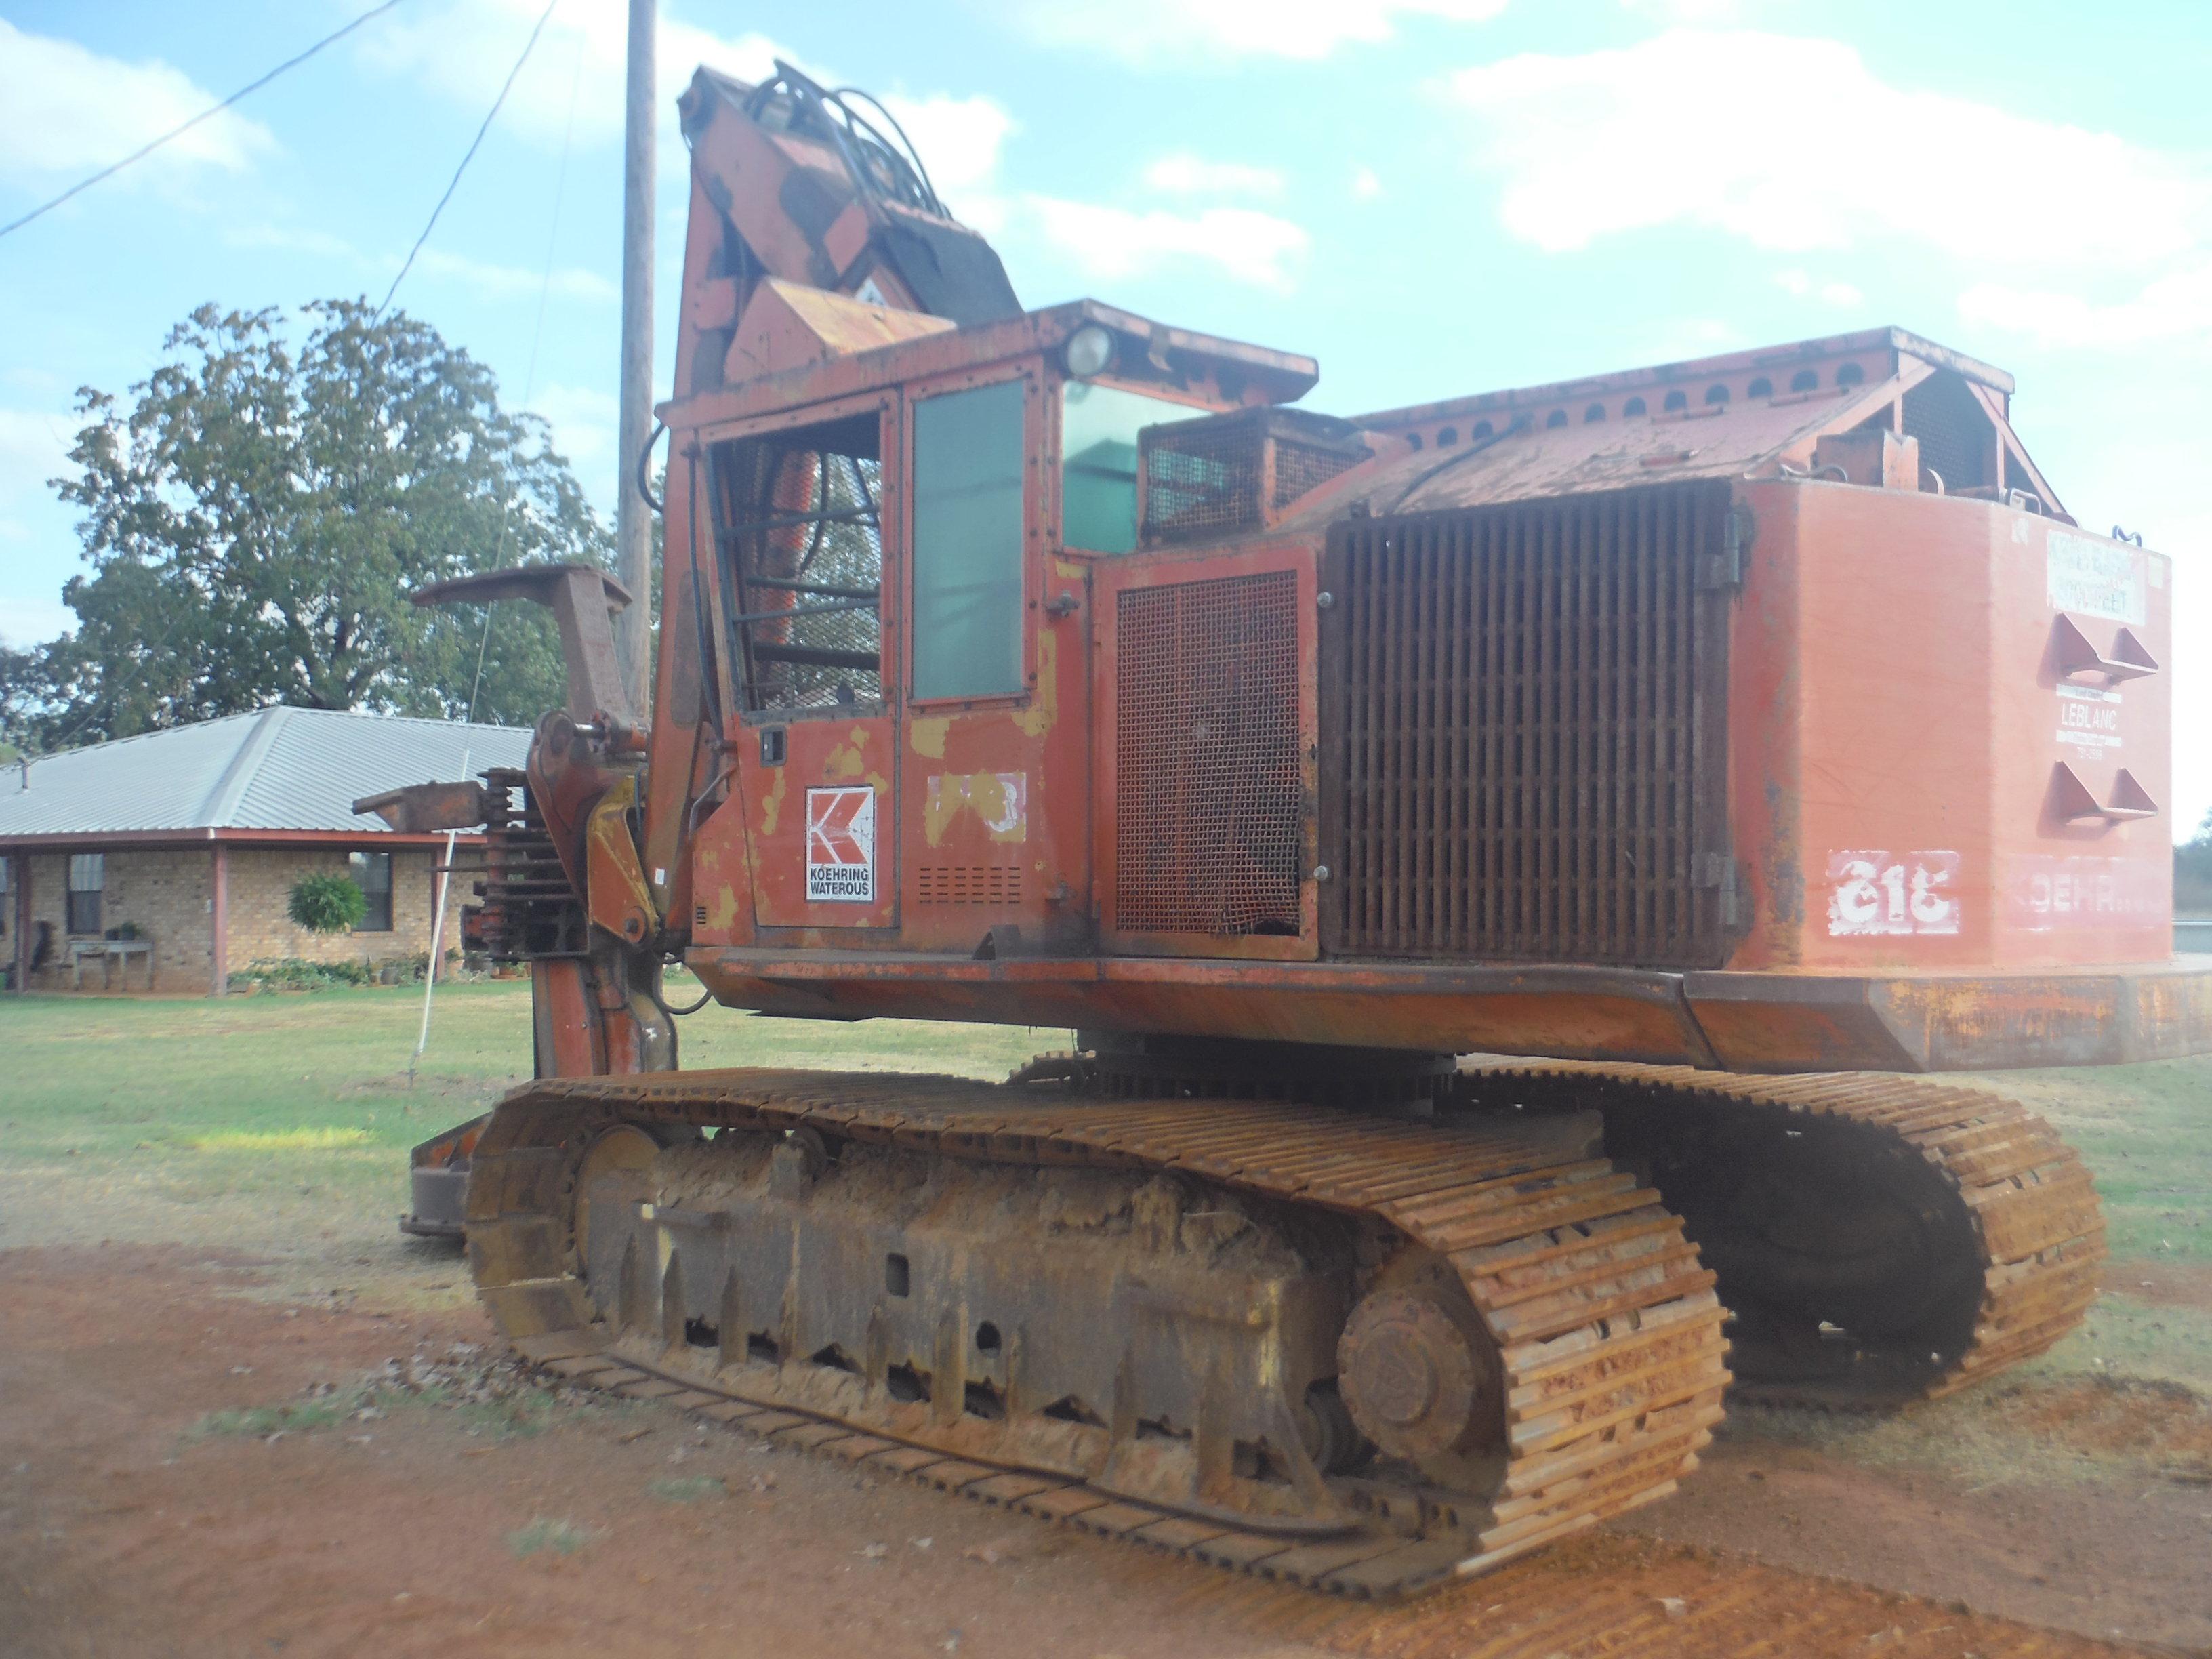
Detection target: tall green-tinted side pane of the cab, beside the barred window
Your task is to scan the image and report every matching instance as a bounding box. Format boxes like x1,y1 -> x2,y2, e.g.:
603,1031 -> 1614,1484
914,380 -> 1024,699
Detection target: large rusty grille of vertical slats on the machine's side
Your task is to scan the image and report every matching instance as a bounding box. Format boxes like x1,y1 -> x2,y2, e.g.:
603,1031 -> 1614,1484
1321,485 -> 1729,966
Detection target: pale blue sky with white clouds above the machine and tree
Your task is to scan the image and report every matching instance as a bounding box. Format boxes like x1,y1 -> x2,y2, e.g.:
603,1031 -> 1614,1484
0,0 -> 2212,832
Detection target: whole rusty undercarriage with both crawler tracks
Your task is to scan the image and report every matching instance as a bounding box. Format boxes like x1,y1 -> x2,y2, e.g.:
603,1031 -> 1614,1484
469,1050 -> 2102,1597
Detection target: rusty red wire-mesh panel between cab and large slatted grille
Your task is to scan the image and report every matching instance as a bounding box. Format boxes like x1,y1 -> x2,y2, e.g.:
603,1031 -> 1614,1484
1113,571 -> 1303,936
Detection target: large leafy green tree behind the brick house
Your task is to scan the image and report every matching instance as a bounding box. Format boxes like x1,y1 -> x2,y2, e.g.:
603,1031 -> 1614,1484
0,301 -> 613,747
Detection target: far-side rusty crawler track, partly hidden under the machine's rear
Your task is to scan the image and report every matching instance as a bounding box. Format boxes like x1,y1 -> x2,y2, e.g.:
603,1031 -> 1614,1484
1460,1062 -> 2106,1409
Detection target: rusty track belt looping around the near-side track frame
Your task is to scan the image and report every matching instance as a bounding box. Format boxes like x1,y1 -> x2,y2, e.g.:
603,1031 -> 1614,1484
469,1071 -> 1727,1597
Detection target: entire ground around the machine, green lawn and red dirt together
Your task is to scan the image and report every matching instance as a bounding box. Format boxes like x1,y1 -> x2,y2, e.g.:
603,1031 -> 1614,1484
0,989 -> 2212,1659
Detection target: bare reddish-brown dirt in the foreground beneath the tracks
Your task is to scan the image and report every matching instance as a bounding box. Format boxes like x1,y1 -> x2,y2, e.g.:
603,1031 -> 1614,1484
0,1243 -> 2212,1659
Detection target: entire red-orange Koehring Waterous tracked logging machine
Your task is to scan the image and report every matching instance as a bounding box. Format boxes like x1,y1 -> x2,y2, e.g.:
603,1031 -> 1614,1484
385,68 -> 2212,1595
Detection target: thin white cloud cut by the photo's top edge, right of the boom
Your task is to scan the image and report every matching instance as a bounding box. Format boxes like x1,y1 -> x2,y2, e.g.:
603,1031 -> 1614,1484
996,0 -> 1507,68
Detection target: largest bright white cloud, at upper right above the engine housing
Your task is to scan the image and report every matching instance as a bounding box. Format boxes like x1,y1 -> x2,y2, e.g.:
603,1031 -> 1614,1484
1447,31 -> 2212,268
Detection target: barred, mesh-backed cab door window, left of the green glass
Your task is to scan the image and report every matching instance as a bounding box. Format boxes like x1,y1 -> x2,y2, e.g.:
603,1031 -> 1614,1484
712,413 -> 882,710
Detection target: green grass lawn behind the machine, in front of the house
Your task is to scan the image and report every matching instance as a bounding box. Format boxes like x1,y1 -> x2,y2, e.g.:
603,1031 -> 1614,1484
0,980 -> 2212,1385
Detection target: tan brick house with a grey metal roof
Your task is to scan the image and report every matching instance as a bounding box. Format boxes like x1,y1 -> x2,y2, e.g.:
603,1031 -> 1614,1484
0,708 -> 531,996
